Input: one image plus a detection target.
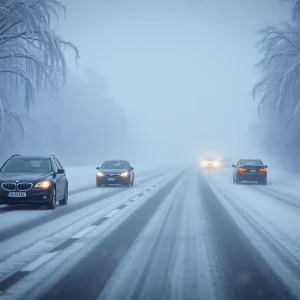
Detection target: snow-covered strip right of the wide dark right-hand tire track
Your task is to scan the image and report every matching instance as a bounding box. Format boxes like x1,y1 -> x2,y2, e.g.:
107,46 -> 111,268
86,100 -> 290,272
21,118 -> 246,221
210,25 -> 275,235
205,171 -> 300,295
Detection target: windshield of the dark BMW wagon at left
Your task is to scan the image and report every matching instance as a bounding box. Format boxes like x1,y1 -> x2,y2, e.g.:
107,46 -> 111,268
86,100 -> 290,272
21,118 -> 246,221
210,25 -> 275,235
1,157 -> 51,173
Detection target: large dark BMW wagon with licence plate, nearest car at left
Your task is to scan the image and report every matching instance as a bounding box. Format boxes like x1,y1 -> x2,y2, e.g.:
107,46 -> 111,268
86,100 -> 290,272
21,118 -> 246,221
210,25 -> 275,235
0,154 -> 68,209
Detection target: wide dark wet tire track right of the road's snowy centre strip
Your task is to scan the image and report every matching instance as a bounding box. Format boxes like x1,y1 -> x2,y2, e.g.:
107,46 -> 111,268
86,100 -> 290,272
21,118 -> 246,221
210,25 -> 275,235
199,175 -> 293,300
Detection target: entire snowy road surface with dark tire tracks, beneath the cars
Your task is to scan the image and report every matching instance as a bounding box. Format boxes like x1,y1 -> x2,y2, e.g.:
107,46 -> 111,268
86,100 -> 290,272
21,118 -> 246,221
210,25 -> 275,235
0,168 -> 300,300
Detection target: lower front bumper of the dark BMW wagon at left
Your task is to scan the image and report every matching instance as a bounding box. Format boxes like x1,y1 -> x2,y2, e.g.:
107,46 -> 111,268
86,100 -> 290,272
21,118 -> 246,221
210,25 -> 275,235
0,189 -> 52,205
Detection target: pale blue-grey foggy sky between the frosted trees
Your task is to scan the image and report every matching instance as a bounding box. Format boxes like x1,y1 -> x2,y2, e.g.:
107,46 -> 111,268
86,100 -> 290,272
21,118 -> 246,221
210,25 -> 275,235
60,0 -> 289,162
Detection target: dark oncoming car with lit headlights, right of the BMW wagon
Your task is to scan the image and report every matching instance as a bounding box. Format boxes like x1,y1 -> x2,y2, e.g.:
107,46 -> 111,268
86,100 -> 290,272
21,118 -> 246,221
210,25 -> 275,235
96,160 -> 134,187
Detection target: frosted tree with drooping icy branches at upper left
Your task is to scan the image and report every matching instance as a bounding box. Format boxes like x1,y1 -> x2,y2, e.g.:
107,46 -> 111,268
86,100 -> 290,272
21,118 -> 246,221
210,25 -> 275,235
0,0 -> 79,156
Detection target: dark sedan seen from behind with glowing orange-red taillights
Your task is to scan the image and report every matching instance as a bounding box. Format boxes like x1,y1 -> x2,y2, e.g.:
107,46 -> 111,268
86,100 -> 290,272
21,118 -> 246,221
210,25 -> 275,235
232,159 -> 268,185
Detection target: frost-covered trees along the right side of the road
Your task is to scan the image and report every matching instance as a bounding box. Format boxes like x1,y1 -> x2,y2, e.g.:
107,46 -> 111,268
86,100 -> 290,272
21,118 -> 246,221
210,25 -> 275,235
253,0 -> 300,171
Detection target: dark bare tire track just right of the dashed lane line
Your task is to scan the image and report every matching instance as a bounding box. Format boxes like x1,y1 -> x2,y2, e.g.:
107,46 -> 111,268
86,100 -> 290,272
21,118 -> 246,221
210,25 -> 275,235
36,173 -> 183,300
